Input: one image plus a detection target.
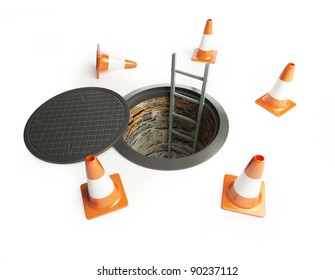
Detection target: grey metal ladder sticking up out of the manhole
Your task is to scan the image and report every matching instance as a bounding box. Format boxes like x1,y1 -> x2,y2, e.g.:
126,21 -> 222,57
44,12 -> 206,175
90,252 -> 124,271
168,53 -> 209,158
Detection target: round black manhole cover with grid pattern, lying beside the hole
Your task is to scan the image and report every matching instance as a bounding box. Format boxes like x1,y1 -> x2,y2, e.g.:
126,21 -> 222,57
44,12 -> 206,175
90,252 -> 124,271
24,87 -> 129,163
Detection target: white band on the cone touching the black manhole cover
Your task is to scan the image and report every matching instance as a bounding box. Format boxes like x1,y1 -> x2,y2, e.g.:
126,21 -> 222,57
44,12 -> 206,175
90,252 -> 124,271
87,175 -> 114,199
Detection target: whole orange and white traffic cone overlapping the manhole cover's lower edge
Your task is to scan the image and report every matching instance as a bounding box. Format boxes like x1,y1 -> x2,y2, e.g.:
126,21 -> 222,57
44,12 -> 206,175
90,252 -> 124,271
80,155 -> 128,220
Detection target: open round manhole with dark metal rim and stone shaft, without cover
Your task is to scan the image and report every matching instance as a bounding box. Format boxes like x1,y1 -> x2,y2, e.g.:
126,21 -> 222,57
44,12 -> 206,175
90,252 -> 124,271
115,85 -> 229,170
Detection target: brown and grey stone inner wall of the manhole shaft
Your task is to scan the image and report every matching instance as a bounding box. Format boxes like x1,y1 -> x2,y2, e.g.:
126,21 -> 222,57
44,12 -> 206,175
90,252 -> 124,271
123,96 -> 217,158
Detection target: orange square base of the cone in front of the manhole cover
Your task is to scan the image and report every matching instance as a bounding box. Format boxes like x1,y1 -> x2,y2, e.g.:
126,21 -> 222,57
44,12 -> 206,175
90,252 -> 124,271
80,174 -> 128,220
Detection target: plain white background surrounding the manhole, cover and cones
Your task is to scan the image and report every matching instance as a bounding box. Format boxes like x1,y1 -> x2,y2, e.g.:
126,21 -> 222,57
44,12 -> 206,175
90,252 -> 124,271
0,0 -> 335,280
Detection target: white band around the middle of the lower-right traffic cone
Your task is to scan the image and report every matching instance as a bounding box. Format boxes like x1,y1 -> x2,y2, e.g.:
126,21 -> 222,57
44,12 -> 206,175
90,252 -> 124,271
234,172 -> 262,198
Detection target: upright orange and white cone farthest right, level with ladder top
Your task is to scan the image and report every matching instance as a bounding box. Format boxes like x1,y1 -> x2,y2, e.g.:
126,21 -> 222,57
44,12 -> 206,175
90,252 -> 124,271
256,63 -> 296,117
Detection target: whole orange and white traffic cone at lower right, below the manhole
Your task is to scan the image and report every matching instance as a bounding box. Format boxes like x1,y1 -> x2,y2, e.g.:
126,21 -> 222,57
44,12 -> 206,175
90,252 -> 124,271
221,155 -> 265,217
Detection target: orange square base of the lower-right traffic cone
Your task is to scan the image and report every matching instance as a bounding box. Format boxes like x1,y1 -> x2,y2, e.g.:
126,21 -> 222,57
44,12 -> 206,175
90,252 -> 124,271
221,174 -> 265,218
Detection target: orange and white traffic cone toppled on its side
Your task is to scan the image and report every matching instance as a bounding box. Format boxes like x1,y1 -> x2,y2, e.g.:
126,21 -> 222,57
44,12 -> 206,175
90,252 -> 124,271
96,44 -> 137,79
